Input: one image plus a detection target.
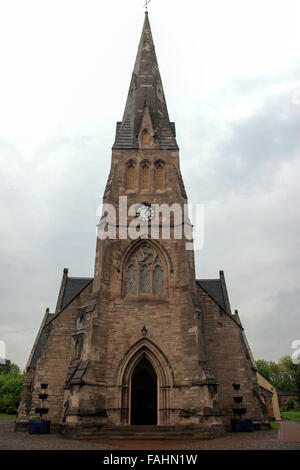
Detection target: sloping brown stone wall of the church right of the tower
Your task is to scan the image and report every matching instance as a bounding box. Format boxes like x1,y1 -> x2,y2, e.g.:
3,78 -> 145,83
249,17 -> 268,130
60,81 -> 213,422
198,286 -> 265,429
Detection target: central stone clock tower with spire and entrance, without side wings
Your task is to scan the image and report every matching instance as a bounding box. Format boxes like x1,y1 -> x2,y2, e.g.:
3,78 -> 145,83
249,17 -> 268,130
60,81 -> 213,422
63,11 -> 223,435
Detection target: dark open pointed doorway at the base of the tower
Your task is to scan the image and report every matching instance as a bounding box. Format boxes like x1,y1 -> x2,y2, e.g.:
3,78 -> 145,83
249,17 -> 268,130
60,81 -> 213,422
131,357 -> 157,426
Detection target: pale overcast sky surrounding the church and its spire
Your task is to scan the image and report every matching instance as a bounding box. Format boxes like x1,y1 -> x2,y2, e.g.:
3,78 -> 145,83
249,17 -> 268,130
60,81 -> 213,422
0,0 -> 300,367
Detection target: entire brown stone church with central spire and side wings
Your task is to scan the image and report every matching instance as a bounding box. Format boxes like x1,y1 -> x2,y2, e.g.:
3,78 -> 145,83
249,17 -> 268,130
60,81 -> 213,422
16,12 -> 265,438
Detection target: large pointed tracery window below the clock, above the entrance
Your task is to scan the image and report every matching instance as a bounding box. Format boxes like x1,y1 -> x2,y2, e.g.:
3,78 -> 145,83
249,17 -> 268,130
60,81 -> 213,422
125,243 -> 165,296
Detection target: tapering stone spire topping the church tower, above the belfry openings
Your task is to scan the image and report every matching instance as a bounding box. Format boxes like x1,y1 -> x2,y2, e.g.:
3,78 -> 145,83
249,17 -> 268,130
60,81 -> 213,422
113,11 -> 178,149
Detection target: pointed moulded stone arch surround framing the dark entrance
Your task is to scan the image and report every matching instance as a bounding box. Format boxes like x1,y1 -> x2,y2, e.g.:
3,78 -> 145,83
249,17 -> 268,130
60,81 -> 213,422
117,338 -> 174,425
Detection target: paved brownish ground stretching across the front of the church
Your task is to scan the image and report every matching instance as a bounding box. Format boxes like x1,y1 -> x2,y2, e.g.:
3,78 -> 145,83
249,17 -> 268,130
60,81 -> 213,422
0,421 -> 300,451
